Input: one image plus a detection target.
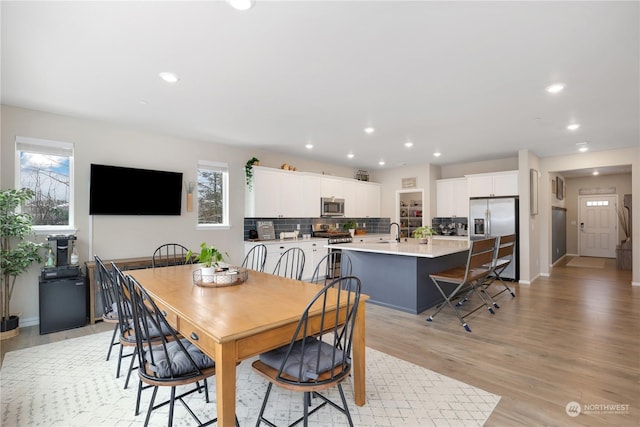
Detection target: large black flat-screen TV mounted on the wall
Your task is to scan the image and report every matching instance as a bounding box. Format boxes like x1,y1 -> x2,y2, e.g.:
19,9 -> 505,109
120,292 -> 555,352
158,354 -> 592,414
89,164 -> 182,215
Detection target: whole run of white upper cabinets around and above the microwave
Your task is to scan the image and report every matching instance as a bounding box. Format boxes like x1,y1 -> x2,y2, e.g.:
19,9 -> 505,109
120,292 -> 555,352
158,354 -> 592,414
245,166 -> 380,218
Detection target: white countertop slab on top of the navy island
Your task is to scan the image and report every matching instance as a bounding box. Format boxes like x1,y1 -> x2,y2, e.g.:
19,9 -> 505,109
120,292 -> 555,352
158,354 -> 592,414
326,239 -> 469,258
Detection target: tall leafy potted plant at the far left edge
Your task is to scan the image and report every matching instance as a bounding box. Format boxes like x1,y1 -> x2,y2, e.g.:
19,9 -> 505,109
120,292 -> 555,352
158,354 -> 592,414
0,188 -> 44,338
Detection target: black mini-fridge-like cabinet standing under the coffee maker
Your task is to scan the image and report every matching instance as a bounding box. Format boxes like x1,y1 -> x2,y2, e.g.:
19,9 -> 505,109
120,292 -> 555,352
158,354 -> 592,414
40,275 -> 87,335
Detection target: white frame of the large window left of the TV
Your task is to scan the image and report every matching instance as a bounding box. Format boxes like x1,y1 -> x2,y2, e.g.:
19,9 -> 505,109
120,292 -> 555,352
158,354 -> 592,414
14,135 -> 77,234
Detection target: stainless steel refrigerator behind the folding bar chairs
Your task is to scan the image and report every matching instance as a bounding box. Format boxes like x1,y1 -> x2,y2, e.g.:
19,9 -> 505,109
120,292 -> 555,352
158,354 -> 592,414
469,197 -> 520,281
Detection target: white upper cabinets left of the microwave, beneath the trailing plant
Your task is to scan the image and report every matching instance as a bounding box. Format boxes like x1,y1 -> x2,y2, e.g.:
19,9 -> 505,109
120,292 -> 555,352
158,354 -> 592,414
245,166 -> 304,218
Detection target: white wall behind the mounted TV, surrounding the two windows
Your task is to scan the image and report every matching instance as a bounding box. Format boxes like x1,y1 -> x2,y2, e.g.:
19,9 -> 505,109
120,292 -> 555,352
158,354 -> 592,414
0,105 -> 355,325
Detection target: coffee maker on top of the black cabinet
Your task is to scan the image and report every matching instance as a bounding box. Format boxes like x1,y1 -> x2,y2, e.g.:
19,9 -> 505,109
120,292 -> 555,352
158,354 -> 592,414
42,234 -> 81,279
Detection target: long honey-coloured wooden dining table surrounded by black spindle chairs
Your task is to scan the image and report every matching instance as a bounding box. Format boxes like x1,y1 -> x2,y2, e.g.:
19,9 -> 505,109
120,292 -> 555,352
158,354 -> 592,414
125,264 -> 368,427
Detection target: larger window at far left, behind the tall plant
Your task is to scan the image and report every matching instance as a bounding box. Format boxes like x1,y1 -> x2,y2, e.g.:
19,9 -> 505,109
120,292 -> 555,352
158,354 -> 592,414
16,136 -> 73,230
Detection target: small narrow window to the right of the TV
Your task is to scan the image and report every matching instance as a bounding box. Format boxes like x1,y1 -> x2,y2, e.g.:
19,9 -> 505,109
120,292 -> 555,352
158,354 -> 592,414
198,160 -> 229,226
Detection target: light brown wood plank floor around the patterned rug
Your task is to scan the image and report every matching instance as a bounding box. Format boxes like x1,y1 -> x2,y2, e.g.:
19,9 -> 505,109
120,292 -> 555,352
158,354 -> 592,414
0,257 -> 640,426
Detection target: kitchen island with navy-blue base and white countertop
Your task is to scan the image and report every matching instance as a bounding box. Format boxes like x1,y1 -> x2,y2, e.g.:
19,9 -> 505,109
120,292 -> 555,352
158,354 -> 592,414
327,239 -> 469,314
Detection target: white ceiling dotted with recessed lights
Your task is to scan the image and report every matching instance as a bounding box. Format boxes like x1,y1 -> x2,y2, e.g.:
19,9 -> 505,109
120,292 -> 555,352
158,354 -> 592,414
0,0 -> 640,169
